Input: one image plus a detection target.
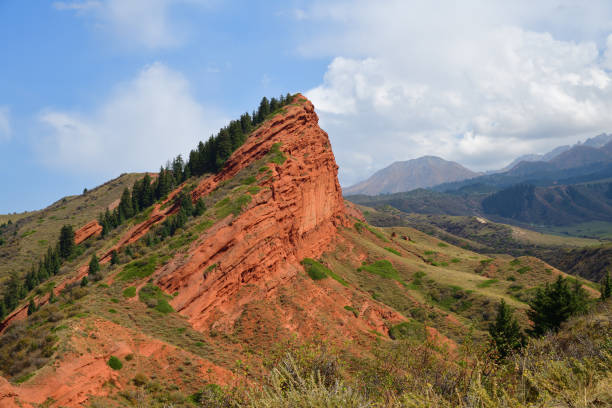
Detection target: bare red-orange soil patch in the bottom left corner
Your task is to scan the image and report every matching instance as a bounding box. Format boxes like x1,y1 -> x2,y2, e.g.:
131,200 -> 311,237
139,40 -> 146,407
0,320 -> 235,408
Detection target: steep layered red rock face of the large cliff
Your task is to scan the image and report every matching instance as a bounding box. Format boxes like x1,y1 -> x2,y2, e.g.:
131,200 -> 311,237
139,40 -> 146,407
158,95 -> 349,330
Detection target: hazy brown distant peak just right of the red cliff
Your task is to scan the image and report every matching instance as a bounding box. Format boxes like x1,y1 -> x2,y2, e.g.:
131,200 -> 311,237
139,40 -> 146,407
343,156 -> 481,195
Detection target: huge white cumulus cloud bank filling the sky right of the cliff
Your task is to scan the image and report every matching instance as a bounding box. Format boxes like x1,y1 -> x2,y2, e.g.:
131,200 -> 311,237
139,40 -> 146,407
300,0 -> 612,185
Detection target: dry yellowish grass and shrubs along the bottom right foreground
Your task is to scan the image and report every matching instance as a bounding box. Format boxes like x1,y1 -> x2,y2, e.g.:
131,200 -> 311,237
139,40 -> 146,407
241,306 -> 612,408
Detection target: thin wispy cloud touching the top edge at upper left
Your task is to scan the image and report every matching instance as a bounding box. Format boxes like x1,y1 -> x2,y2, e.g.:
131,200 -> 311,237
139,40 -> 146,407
53,0 -> 207,48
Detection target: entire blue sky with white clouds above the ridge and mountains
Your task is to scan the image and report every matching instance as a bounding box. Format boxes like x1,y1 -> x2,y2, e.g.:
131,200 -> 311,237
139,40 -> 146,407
0,0 -> 612,213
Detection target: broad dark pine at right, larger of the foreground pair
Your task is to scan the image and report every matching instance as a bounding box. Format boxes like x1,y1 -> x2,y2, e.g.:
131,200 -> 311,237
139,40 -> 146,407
527,276 -> 588,336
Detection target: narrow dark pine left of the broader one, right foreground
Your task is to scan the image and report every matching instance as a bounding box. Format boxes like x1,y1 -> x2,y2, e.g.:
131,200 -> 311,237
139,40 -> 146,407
489,299 -> 525,360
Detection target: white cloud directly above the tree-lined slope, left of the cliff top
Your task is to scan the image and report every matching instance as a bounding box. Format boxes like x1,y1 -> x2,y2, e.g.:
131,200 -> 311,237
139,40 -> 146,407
36,63 -> 225,176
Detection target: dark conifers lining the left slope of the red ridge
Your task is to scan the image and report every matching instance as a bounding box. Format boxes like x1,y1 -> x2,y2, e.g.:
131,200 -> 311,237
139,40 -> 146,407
0,94 -> 293,319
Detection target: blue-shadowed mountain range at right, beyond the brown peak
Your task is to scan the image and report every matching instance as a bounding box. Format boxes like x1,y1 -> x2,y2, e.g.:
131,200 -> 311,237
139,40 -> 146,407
349,134 -> 612,233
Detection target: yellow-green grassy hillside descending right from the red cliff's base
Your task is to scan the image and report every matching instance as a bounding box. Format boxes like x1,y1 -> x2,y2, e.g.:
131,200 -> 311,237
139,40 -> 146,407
322,218 -> 586,342
